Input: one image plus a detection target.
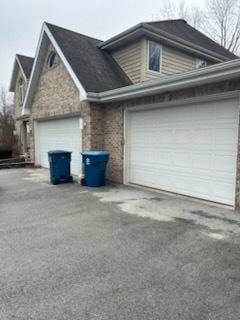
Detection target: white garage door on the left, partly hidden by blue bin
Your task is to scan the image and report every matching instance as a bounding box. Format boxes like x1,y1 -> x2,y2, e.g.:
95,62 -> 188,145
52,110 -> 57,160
36,118 -> 82,175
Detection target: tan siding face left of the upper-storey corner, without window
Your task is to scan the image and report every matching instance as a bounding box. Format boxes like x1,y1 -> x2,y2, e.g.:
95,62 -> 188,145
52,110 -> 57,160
112,41 -> 142,83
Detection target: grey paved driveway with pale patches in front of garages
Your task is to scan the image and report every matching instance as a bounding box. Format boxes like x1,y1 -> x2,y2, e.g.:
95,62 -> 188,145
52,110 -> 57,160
0,169 -> 240,320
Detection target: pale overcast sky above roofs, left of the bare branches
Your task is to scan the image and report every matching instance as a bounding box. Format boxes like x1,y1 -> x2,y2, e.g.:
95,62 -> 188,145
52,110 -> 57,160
0,0 -> 199,89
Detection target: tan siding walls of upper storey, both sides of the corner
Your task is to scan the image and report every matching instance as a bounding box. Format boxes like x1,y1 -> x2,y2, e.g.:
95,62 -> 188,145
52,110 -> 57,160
112,38 -> 211,83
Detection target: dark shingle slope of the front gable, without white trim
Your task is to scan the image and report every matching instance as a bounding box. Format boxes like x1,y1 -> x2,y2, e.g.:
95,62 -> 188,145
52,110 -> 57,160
46,23 -> 131,92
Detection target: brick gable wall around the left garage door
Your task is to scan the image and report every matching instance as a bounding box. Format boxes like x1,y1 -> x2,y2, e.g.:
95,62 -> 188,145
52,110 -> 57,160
30,44 -> 102,161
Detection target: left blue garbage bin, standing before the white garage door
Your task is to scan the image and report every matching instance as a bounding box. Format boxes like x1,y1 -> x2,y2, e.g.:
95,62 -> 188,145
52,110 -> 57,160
48,150 -> 73,184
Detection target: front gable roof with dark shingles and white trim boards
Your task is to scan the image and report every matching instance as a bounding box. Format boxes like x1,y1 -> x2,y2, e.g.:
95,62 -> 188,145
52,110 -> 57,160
22,23 -> 131,114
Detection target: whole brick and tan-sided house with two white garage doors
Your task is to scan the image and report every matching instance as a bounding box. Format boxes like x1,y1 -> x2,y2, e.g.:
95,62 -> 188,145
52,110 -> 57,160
10,20 -> 240,208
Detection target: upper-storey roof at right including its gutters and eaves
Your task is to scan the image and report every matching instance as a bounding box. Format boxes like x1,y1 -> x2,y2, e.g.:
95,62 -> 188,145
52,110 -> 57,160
99,19 -> 238,62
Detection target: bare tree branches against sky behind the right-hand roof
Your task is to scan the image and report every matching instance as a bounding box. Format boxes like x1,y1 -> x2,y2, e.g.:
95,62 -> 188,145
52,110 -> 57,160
157,0 -> 240,53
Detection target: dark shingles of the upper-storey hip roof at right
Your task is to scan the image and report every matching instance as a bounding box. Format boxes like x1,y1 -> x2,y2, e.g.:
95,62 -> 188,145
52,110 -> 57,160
147,19 -> 237,59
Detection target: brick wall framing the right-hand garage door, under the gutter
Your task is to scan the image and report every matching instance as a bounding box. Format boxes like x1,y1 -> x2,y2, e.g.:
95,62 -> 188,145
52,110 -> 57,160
96,80 -> 240,208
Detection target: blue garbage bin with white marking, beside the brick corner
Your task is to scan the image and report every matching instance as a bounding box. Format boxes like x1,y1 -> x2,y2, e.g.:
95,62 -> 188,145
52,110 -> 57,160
81,150 -> 109,187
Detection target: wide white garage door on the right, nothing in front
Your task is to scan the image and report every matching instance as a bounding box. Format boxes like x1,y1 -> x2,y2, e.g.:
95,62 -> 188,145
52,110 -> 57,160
126,99 -> 239,205
